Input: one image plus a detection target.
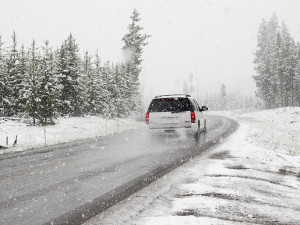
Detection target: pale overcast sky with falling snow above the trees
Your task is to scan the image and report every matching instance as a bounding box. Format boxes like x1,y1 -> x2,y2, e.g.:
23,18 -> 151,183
0,0 -> 300,102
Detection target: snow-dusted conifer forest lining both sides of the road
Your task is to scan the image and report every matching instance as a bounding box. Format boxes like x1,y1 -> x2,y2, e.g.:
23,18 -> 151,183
0,10 -> 300,125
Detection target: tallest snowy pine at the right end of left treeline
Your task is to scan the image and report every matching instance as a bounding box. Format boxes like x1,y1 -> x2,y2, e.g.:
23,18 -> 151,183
122,9 -> 150,111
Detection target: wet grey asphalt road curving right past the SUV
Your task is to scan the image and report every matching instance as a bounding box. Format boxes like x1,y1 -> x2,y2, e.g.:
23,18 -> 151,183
0,116 -> 237,225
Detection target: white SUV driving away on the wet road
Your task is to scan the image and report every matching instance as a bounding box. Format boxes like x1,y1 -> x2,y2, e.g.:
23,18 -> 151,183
146,94 -> 208,132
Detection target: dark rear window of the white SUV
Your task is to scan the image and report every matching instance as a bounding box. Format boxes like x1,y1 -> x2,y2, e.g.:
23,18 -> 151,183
148,98 -> 192,112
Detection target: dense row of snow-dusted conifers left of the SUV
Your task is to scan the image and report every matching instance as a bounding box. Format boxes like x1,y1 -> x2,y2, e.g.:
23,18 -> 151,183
0,10 -> 149,124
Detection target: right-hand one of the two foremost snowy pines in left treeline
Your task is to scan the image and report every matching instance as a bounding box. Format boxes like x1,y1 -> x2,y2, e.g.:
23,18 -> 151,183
37,41 -> 60,126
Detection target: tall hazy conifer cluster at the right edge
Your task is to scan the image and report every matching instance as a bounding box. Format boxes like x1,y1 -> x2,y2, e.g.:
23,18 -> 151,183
254,14 -> 300,109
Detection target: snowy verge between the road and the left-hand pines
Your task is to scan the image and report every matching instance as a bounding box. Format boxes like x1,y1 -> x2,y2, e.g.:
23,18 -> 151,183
0,116 -> 145,154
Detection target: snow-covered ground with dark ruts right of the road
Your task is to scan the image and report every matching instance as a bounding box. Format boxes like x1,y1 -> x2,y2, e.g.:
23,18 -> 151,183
86,107 -> 300,225
